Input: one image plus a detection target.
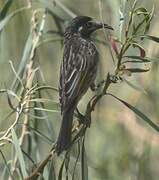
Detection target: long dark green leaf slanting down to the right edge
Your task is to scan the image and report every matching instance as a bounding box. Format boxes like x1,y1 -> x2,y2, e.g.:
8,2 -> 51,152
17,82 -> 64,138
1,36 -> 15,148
106,93 -> 159,132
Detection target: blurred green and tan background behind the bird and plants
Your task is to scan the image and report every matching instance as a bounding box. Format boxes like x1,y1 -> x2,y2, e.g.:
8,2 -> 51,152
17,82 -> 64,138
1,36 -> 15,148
0,0 -> 159,180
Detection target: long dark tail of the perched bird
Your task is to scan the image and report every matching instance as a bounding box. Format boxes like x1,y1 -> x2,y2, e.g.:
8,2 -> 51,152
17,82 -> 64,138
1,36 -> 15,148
56,108 -> 74,155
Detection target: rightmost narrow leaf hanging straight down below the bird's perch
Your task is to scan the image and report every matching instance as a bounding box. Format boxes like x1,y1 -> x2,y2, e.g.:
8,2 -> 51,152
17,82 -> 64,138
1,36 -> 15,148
81,137 -> 88,180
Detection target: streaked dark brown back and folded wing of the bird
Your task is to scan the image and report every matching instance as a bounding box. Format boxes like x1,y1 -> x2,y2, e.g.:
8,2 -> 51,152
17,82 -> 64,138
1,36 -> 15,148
59,39 -> 98,112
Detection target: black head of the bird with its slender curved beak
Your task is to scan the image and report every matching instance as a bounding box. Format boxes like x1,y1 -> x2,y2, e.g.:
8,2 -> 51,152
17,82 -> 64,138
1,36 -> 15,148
66,16 -> 113,37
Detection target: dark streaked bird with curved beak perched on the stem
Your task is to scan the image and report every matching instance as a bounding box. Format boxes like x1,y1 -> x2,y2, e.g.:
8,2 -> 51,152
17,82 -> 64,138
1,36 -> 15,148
56,16 -> 113,155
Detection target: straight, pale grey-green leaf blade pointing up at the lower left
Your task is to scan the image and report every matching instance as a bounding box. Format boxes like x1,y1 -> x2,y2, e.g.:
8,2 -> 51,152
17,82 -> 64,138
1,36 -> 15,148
11,128 -> 28,178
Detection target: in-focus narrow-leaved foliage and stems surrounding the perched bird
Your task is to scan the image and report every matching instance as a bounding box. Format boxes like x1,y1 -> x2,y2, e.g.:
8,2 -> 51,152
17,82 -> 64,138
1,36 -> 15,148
0,0 -> 159,180
